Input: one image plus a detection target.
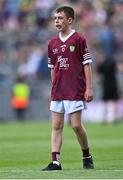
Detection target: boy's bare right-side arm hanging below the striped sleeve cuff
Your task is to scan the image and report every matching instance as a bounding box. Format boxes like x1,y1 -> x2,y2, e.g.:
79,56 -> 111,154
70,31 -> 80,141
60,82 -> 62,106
84,64 -> 93,102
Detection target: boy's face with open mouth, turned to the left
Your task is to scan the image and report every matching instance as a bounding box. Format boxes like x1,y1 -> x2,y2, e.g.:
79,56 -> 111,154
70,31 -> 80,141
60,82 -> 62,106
54,11 -> 73,32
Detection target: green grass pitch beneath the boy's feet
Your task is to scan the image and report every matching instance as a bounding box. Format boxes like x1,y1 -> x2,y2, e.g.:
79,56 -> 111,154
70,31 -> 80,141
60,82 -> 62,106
0,121 -> 123,179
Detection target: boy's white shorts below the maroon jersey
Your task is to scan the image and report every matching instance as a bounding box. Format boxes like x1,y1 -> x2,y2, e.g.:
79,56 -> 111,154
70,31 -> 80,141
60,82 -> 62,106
50,100 -> 87,114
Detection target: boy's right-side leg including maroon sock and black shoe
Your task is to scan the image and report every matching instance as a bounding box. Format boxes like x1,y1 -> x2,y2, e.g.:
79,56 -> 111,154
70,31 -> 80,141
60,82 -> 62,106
71,111 -> 94,169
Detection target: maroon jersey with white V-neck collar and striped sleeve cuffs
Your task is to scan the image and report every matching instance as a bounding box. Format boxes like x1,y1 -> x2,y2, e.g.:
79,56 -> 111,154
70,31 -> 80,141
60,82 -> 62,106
48,30 -> 92,100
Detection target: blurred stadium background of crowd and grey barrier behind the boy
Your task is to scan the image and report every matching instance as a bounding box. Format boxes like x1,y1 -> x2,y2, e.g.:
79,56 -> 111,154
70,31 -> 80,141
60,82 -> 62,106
0,0 -> 123,122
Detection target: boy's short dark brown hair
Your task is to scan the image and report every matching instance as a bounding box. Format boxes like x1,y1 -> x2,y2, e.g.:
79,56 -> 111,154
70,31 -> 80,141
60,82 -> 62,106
55,6 -> 74,20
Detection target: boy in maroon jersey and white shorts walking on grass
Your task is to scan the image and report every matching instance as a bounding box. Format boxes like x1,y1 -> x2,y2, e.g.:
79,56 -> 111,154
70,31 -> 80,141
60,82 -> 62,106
43,6 -> 94,171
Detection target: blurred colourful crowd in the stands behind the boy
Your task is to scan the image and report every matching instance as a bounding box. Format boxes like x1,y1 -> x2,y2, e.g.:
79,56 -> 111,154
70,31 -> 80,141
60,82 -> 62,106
0,0 -> 123,100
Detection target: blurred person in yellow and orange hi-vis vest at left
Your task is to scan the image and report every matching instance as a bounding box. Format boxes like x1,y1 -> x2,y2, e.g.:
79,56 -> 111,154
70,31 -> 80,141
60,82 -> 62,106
11,76 -> 30,121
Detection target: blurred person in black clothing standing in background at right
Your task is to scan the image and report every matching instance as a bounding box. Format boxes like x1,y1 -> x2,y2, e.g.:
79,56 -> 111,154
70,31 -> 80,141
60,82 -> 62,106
98,57 -> 119,124
